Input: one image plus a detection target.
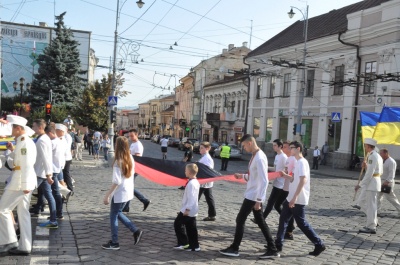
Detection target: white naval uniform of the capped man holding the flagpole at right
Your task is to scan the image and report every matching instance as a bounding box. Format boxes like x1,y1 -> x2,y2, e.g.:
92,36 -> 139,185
359,150 -> 383,230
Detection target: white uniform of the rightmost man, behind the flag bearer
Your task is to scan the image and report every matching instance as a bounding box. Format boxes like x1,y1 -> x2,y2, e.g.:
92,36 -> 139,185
378,156 -> 400,212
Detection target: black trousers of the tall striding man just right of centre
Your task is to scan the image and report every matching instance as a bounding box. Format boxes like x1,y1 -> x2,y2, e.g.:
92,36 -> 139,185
231,199 -> 276,251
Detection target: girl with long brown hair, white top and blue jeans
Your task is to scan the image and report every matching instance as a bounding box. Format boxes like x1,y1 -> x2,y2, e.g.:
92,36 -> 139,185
102,136 -> 143,250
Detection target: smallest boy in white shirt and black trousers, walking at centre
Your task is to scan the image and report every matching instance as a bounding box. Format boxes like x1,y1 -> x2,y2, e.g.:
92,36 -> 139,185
174,164 -> 200,251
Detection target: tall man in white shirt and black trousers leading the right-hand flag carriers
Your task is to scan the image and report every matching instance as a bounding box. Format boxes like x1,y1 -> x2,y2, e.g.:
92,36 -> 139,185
219,134 -> 280,259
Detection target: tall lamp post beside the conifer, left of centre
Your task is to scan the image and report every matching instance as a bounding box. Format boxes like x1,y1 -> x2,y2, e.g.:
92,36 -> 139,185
108,0 -> 144,165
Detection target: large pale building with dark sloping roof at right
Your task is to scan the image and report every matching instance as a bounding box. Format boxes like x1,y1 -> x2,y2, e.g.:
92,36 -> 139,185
246,0 -> 400,167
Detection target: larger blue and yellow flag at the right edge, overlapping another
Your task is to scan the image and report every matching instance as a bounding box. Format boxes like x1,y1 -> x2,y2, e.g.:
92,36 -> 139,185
372,107 -> 400,145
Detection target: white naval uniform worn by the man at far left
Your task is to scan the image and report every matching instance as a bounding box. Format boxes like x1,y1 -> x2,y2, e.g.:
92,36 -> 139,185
0,134 -> 37,252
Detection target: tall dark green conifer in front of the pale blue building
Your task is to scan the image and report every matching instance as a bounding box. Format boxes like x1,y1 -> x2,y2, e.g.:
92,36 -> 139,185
32,12 -> 85,109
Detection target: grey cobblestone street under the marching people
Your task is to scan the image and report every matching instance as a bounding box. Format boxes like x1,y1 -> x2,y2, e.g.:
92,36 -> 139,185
0,141 -> 400,264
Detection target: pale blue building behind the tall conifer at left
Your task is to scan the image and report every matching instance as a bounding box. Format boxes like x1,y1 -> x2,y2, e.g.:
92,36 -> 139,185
1,21 -> 92,97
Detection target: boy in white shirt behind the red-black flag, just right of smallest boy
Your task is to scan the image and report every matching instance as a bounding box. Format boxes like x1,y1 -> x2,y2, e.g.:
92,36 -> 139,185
199,142 -> 217,221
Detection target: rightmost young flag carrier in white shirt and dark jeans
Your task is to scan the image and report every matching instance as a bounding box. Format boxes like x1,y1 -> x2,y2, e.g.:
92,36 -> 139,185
276,141 -> 326,256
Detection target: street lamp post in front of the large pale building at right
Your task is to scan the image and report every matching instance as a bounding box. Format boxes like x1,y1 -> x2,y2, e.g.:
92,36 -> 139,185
288,5 -> 308,141
